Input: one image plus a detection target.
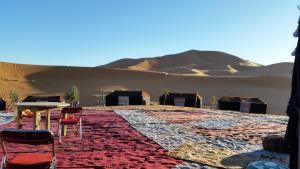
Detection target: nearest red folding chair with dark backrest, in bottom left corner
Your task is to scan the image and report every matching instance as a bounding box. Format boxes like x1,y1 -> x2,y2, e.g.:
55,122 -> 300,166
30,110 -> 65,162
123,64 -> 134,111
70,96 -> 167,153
0,129 -> 56,169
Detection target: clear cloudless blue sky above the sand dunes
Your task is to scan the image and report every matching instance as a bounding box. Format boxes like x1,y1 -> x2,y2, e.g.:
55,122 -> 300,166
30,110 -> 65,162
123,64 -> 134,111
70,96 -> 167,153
0,0 -> 299,66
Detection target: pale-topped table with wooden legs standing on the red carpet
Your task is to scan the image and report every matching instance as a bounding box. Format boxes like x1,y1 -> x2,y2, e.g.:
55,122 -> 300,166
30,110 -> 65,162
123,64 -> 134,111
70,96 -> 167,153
15,102 -> 70,130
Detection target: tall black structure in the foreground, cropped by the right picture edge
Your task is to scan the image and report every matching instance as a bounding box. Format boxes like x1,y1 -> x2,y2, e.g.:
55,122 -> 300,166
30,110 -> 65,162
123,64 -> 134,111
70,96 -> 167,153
285,15 -> 300,169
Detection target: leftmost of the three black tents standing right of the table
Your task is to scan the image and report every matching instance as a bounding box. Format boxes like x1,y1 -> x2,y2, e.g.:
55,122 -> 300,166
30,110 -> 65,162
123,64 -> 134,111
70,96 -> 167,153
105,91 -> 150,106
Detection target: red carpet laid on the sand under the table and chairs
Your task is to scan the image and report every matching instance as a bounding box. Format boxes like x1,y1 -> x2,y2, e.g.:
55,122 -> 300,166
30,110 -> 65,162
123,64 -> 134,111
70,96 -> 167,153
0,110 -> 182,169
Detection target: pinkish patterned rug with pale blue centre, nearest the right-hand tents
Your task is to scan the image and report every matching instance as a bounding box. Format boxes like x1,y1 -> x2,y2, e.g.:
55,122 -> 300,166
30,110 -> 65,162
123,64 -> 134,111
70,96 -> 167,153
147,111 -> 287,145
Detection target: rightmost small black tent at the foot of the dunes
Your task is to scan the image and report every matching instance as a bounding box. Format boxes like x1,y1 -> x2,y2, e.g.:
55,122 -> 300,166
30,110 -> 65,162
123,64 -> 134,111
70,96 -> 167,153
218,96 -> 267,114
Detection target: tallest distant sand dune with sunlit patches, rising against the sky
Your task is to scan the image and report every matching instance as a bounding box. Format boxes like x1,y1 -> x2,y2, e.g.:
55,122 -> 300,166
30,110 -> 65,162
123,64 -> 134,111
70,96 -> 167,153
101,50 -> 293,77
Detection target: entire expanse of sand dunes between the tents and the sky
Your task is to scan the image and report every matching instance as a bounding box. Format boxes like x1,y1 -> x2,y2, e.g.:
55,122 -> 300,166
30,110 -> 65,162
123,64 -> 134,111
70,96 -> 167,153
0,50 -> 293,114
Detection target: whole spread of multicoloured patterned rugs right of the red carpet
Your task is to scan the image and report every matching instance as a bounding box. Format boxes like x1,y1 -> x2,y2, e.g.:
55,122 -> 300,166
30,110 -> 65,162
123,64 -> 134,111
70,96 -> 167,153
116,110 -> 288,168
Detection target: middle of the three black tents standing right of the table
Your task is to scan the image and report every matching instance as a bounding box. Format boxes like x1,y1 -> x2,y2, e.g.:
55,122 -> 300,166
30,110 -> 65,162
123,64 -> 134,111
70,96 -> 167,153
159,93 -> 202,108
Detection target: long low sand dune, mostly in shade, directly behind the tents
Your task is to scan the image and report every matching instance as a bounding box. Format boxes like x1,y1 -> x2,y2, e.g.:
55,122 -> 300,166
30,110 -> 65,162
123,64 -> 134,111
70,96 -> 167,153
0,63 -> 291,115
